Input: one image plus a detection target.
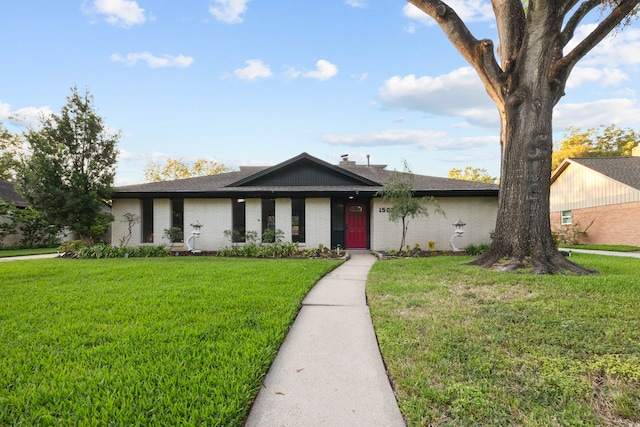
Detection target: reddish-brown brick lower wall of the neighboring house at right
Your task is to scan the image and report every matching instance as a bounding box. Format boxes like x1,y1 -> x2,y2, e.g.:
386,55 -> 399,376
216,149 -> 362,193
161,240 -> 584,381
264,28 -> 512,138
551,202 -> 640,246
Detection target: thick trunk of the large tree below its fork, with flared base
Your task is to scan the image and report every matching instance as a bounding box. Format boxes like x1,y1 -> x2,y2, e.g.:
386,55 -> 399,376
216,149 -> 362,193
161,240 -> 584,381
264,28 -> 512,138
472,100 -> 592,274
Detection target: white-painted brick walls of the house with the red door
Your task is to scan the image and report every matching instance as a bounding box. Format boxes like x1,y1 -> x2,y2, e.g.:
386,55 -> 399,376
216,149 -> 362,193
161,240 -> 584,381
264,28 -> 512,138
113,197 -> 498,250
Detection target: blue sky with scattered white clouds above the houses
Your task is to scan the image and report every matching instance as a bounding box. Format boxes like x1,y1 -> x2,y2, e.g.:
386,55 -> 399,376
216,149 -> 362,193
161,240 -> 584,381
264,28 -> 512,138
0,0 -> 640,185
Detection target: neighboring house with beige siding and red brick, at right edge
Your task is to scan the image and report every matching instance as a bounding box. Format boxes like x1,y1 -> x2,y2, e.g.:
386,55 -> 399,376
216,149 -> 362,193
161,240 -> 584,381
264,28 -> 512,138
550,147 -> 640,246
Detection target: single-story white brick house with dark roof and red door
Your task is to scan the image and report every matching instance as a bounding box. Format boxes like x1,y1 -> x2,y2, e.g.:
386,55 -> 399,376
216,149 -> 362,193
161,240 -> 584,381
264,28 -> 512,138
112,153 -> 498,250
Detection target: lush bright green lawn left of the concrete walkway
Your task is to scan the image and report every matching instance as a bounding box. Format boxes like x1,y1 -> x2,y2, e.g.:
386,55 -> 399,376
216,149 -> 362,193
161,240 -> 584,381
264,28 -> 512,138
0,257 -> 339,426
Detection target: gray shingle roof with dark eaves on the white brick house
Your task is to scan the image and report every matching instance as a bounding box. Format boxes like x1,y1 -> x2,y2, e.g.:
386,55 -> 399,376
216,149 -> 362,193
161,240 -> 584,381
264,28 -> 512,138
114,153 -> 498,198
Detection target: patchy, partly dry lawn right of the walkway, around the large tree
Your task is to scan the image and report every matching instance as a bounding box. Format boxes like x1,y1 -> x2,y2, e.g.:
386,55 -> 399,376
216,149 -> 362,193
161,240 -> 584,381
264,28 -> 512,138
367,254 -> 640,426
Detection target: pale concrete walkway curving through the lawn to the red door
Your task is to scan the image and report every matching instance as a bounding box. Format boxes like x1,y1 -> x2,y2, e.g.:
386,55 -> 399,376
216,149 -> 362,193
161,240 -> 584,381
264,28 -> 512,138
245,252 -> 405,427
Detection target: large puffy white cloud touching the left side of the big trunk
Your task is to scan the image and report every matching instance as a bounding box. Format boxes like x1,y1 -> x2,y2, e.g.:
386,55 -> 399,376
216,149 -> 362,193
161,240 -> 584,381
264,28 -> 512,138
378,67 -> 497,123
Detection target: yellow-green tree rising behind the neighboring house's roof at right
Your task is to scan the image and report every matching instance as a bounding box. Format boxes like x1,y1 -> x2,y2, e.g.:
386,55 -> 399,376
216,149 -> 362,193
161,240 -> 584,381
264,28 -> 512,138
551,124 -> 640,170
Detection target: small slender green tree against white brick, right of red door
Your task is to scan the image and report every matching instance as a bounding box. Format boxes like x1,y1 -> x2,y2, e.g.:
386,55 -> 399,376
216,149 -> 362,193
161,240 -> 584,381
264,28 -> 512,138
376,161 -> 444,250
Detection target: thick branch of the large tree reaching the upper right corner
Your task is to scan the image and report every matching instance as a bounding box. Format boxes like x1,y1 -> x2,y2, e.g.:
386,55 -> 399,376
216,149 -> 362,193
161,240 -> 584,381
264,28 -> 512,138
549,0 -> 640,81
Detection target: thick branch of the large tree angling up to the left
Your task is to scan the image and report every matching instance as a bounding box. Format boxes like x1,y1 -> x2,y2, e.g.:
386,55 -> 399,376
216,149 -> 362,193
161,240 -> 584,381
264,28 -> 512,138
407,0 -> 504,105
